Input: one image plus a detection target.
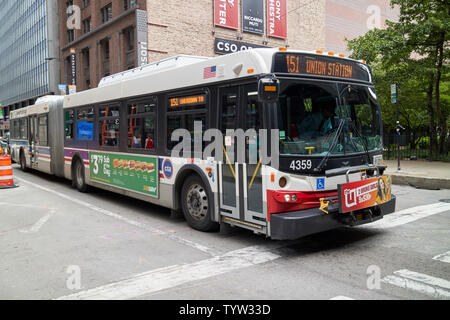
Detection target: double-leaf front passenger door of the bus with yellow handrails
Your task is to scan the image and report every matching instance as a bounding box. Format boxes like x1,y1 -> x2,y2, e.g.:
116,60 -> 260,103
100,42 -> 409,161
219,84 -> 266,229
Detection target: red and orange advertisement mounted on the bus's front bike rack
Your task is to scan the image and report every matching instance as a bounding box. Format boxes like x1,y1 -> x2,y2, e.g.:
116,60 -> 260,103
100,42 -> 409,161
338,176 -> 391,213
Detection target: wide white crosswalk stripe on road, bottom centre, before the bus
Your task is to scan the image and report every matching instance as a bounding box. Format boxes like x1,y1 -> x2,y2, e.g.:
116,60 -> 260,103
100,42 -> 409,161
57,246 -> 280,300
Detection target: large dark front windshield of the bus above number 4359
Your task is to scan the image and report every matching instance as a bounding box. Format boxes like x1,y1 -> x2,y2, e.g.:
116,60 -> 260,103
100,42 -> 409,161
278,80 -> 382,156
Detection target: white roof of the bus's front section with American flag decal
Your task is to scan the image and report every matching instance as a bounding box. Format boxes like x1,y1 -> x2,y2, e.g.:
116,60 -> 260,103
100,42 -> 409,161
64,48 -> 372,108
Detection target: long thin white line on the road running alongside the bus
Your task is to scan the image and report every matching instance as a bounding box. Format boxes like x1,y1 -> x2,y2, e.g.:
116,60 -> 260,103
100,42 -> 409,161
16,177 -> 218,256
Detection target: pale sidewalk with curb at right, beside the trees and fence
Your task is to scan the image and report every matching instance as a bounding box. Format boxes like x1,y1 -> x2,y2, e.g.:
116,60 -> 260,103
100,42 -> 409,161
384,160 -> 450,190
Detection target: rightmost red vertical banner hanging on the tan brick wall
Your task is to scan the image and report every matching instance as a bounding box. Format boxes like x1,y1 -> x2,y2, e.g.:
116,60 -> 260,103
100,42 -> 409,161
267,0 -> 287,39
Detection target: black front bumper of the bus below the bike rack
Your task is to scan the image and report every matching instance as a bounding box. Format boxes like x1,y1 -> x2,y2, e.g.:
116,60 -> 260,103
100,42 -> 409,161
270,195 -> 396,240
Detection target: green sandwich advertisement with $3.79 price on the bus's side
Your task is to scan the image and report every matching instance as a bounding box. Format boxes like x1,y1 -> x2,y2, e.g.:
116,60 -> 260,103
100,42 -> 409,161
89,152 -> 158,197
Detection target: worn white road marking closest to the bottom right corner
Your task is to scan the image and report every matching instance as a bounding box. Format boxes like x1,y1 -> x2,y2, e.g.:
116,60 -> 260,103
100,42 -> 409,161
381,269 -> 450,299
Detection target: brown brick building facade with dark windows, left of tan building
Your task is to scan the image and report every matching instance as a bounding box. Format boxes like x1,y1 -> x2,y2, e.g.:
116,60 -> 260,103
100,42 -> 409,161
59,0 -> 147,91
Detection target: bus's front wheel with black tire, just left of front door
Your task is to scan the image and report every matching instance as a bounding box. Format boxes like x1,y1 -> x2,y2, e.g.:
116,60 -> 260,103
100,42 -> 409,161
181,175 -> 219,232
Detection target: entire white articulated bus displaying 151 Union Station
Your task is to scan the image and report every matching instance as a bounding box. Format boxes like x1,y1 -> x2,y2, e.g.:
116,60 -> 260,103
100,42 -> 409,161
11,48 -> 395,239
